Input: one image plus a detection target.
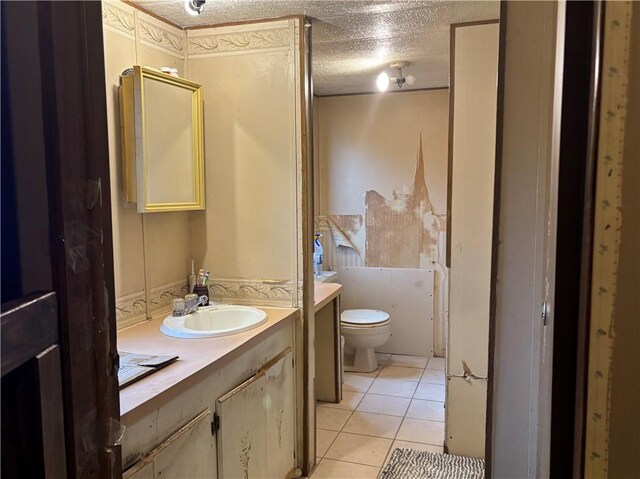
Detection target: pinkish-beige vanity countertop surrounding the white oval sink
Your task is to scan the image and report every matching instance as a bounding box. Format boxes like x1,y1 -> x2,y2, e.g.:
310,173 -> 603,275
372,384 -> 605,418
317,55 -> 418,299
118,308 -> 298,422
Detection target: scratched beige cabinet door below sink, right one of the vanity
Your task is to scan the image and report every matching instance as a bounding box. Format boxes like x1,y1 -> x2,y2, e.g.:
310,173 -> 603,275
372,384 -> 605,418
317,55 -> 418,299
216,348 -> 295,479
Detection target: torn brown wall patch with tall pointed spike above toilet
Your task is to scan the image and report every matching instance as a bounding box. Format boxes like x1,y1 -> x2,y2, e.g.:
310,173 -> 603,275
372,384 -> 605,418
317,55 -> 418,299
365,135 -> 440,268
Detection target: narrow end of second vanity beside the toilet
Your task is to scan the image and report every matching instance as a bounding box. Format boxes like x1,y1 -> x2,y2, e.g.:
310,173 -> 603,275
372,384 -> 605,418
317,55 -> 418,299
314,282 -> 342,403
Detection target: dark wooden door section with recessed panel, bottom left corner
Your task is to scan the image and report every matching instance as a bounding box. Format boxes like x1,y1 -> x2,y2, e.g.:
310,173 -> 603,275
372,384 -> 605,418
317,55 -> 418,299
0,292 -> 67,479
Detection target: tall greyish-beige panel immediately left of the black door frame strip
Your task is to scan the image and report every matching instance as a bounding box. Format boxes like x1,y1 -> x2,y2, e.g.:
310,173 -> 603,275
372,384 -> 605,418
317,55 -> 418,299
485,1 -> 565,477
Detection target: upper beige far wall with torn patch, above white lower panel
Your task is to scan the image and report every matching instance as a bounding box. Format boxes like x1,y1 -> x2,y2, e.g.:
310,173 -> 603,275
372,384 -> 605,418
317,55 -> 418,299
315,89 -> 449,268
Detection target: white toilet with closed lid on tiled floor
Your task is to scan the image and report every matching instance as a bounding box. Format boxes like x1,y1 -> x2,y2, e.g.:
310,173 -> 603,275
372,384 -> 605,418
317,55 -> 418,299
340,309 -> 391,373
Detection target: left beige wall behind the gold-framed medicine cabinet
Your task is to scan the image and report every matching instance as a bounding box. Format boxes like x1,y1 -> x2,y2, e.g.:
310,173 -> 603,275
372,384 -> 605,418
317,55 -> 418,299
103,2 -> 191,327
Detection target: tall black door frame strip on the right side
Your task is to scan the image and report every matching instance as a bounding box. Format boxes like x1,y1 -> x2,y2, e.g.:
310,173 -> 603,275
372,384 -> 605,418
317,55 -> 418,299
549,1 -> 604,478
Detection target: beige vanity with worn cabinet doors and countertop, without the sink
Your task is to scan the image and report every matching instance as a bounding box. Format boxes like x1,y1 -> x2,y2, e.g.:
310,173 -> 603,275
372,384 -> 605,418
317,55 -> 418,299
118,308 -> 300,479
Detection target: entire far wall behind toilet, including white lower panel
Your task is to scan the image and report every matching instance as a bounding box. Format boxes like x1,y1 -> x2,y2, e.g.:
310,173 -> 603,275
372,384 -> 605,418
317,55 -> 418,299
314,89 -> 449,355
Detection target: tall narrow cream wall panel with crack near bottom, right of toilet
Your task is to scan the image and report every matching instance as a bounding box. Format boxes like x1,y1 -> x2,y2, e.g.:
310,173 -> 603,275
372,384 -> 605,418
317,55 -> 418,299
446,23 -> 499,457
